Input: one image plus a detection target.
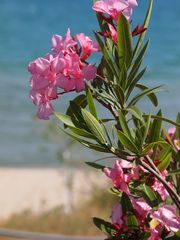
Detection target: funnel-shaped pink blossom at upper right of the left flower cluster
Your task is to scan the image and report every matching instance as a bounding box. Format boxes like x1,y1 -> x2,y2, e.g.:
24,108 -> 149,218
76,33 -> 100,61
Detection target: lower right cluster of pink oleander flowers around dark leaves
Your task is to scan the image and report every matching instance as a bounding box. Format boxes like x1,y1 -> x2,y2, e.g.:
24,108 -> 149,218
104,160 -> 180,240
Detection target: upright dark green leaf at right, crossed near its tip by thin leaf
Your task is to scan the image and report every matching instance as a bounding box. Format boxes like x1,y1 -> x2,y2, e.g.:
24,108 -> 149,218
148,110 -> 162,143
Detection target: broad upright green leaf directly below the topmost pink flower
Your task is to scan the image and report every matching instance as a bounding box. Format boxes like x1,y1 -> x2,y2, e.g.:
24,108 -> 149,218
117,14 -> 133,68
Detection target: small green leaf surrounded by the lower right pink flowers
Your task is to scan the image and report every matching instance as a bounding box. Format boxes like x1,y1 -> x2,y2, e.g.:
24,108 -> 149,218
142,184 -> 158,207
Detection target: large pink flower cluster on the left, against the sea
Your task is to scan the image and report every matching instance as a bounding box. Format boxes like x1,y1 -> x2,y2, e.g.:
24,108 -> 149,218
28,29 -> 100,119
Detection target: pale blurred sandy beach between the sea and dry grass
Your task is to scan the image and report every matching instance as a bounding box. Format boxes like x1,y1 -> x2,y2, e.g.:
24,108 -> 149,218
0,168 -> 107,220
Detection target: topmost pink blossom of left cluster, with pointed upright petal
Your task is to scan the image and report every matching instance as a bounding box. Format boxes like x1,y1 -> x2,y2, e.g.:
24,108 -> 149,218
52,28 -> 77,53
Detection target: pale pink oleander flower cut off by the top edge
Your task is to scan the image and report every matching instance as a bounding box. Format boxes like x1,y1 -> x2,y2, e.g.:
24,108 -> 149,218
93,0 -> 138,21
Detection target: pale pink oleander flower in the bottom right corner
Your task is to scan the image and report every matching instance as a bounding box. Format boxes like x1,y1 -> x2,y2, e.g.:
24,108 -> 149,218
150,205 -> 180,232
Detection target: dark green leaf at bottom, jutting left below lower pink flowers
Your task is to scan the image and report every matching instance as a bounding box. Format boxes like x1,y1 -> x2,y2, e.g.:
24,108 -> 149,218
93,218 -> 116,237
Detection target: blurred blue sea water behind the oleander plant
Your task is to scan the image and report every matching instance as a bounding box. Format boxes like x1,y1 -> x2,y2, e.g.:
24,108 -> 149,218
0,0 -> 180,167
